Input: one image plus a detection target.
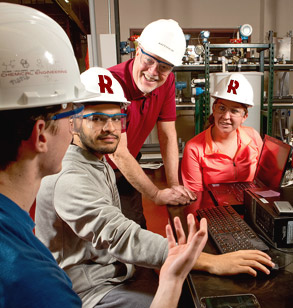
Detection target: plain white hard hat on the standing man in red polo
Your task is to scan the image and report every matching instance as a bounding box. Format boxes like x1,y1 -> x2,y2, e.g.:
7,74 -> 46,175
137,19 -> 186,65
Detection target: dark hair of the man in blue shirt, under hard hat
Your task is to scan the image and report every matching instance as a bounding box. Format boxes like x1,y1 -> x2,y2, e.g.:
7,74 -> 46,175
0,105 -> 61,170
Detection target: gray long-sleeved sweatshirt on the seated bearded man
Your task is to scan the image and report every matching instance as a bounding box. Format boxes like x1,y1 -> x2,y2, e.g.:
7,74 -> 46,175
36,145 -> 168,307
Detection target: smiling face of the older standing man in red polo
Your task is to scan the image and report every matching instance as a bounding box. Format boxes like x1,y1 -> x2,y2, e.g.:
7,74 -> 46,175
132,47 -> 172,94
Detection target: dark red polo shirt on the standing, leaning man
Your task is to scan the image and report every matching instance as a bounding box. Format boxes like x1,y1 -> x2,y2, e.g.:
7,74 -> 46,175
109,59 -> 176,157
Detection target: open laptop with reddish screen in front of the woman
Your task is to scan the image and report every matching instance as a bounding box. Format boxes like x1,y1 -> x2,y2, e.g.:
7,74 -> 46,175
208,135 -> 292,206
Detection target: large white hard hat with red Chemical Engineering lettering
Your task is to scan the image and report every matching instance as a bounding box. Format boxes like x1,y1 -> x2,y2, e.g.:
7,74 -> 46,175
0,3 -> 92,110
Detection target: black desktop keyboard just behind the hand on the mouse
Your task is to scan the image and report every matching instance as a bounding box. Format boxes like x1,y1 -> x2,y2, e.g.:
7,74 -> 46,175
197,205 -> 269,253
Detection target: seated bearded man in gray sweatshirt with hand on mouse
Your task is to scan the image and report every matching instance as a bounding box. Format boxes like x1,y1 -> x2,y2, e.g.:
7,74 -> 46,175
36,68 -> 271,307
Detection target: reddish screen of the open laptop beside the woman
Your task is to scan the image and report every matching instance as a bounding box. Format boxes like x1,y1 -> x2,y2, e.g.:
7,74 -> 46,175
255,135 -> 291,187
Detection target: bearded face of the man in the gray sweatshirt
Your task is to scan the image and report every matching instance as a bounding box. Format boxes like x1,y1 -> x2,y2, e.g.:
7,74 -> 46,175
74,104 -> 121,159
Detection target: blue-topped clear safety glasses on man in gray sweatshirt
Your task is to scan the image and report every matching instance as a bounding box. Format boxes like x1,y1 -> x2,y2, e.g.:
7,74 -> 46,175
83,112 -> 127,130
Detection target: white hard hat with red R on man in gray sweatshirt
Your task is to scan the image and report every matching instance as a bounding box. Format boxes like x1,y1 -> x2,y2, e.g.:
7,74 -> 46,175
79,67 -> 130,107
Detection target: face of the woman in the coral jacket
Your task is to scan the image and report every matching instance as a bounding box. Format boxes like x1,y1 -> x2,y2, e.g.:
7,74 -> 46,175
213,98 -> 248,133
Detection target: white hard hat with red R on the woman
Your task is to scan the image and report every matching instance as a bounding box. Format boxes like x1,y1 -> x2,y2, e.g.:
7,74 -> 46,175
211,73 -> 254,106
